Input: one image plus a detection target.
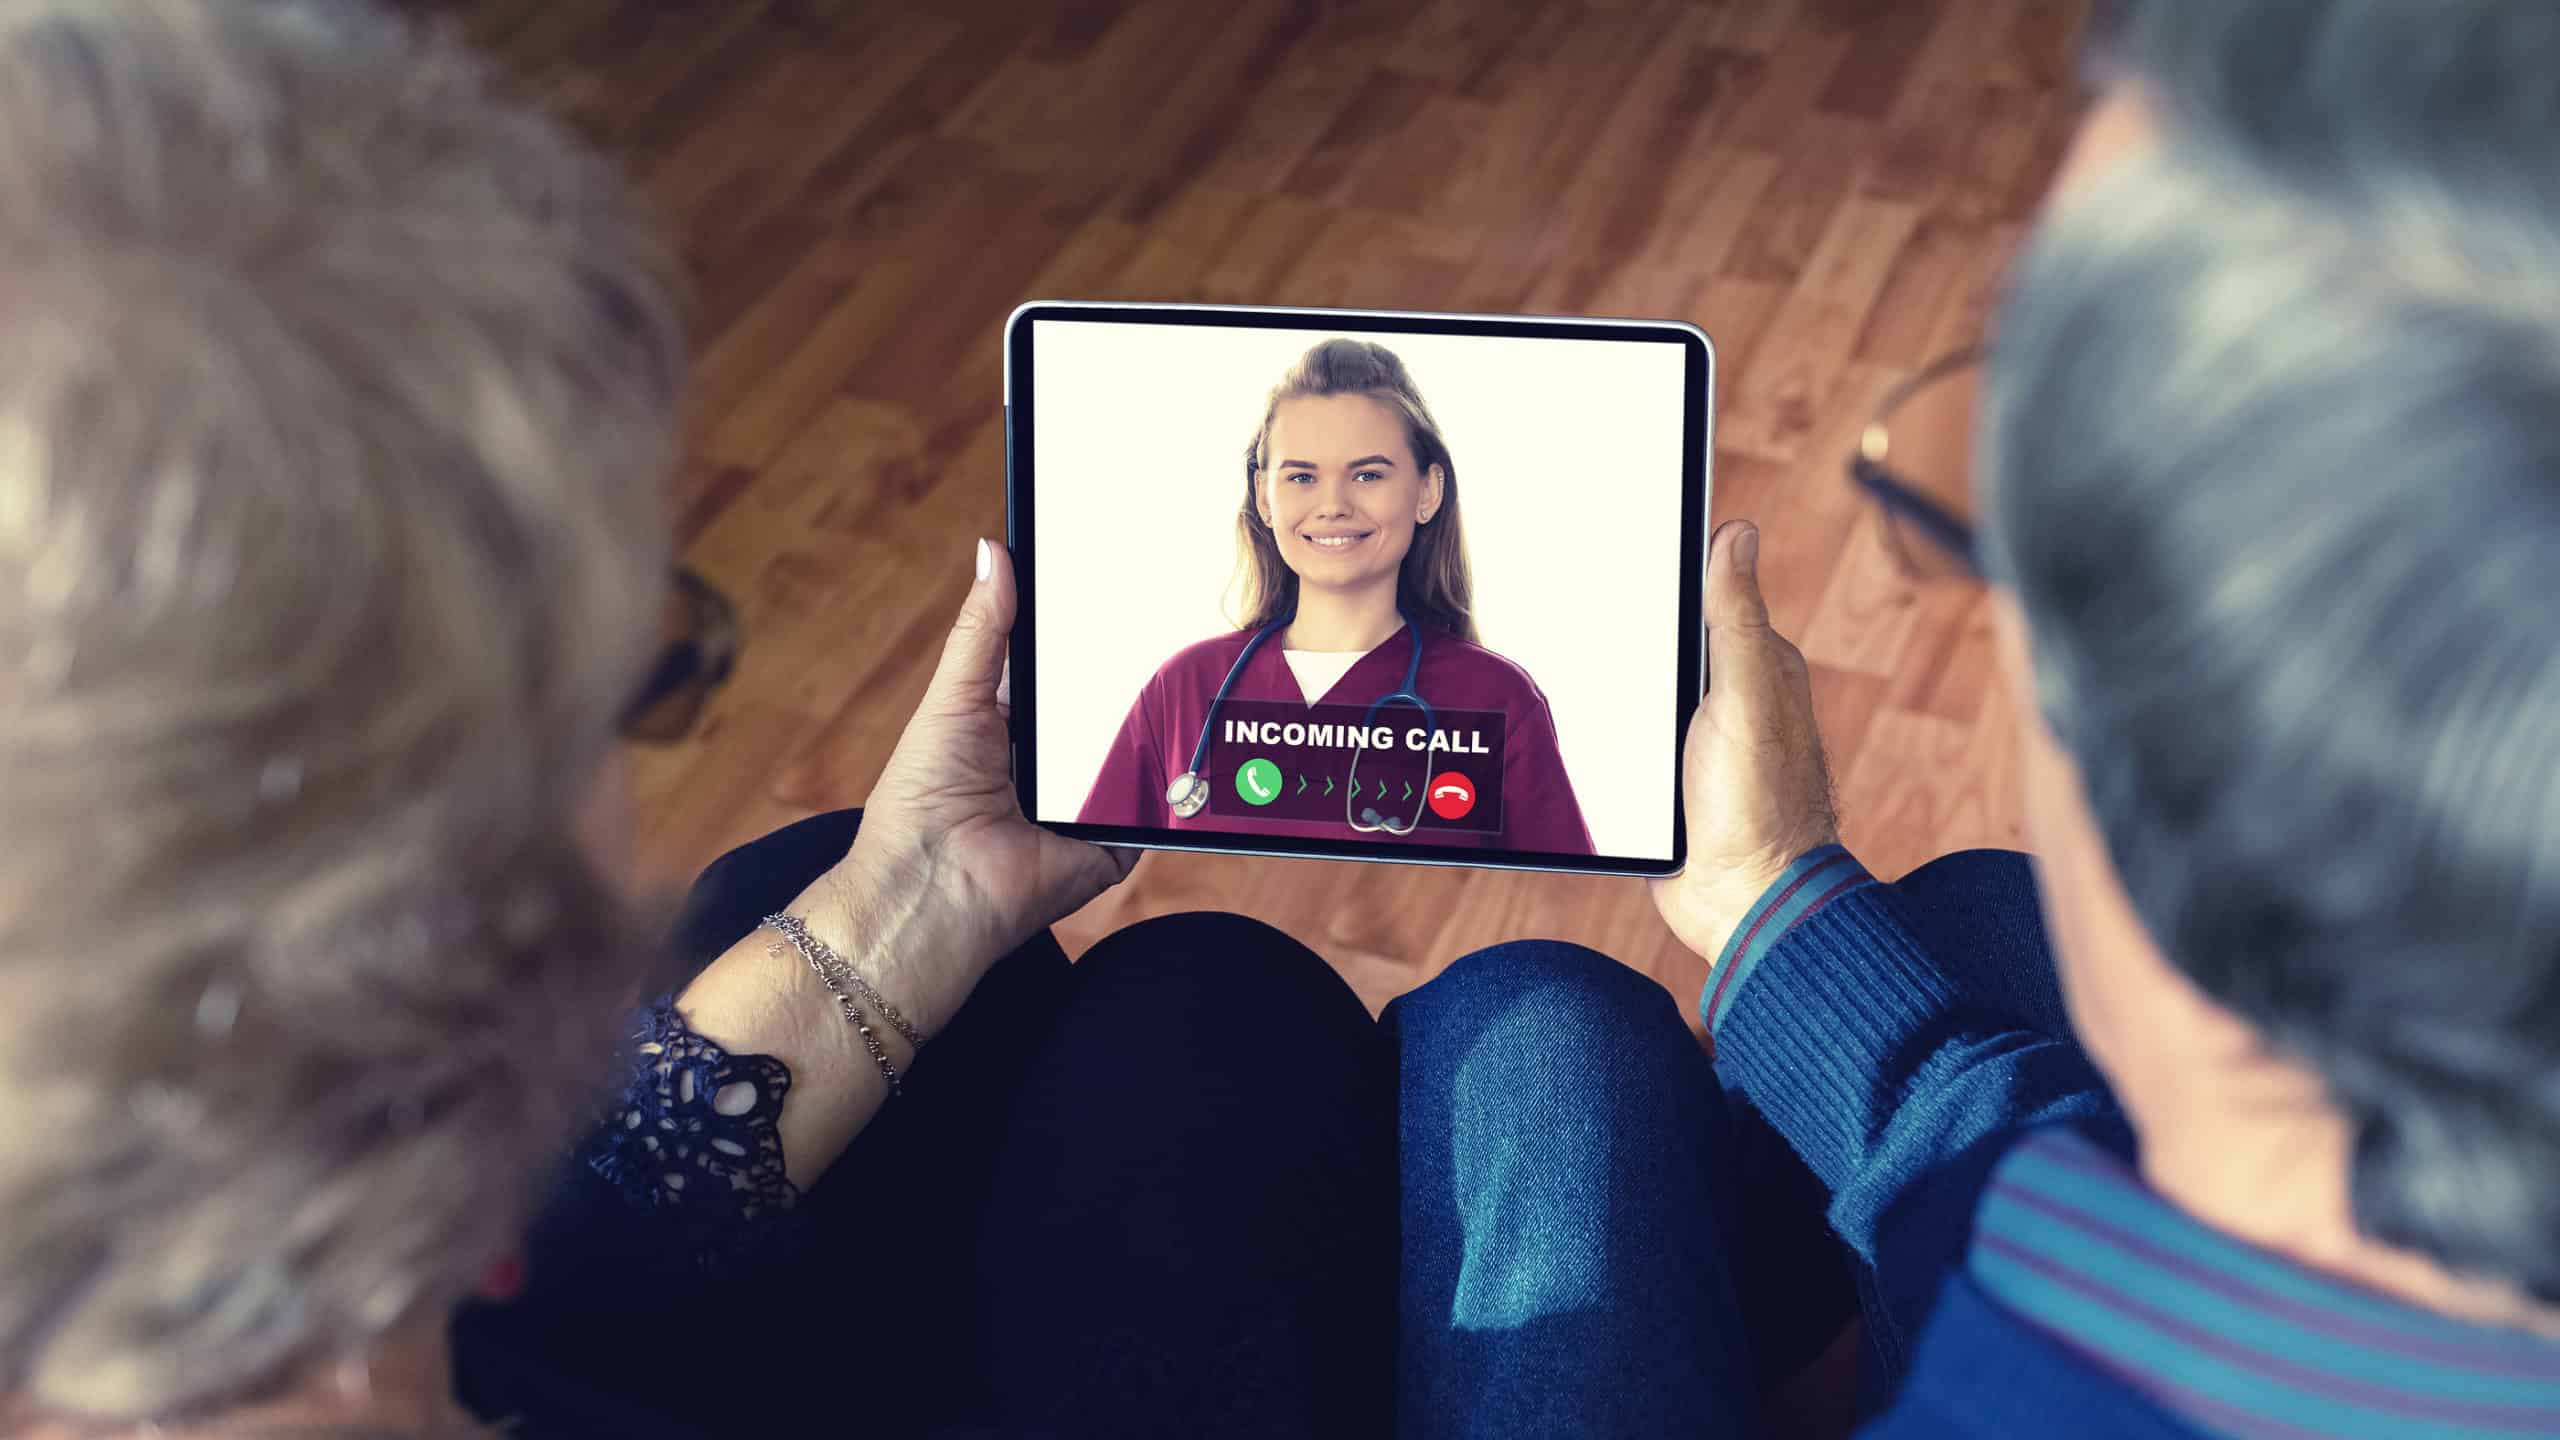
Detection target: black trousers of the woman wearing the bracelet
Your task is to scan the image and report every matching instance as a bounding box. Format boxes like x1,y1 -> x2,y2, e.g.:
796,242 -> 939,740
650,810 -> 1398,1437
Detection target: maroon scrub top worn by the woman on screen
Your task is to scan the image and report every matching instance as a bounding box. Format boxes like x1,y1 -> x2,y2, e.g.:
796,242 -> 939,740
1075,625 -> 1597,856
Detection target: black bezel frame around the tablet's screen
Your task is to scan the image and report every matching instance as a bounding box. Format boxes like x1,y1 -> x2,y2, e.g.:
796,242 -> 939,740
1004,300 -> 1715,876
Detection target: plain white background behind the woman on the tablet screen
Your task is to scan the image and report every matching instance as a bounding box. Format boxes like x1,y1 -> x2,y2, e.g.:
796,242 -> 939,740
1032,320 -> 1684,858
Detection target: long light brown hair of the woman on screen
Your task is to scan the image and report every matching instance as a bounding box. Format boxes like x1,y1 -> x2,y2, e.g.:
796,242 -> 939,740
1236,341 -> 1477,643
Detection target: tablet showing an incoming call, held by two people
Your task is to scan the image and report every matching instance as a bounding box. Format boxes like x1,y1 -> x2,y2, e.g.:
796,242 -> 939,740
1004,302 -> 1715,874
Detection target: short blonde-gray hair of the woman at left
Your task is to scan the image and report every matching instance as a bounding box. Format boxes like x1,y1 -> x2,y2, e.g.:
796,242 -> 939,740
0,0 -> 684,1417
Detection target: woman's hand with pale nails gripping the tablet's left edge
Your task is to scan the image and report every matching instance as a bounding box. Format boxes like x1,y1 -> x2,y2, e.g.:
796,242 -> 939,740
812,541 -> 1137,1030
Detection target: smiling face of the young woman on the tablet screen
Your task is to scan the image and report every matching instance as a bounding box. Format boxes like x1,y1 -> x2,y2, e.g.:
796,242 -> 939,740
1254,395 -> 1444,589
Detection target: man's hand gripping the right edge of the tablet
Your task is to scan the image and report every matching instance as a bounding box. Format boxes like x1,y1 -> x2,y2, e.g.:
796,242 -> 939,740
1651,520 -> 1841,963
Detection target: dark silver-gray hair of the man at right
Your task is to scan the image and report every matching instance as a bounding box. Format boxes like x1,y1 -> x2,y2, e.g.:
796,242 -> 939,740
1979,0 -> 2560,1302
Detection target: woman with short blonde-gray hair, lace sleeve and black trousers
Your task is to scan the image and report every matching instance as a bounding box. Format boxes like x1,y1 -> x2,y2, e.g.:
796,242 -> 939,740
0,0 -> 1395,1437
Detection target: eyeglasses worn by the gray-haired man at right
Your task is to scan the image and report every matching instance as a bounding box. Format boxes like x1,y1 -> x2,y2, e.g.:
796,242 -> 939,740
1848,346 -> 1989,582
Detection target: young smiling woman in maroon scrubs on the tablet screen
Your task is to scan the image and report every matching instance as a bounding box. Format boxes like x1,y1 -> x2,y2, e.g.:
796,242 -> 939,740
1078,341 -> 1595,856
